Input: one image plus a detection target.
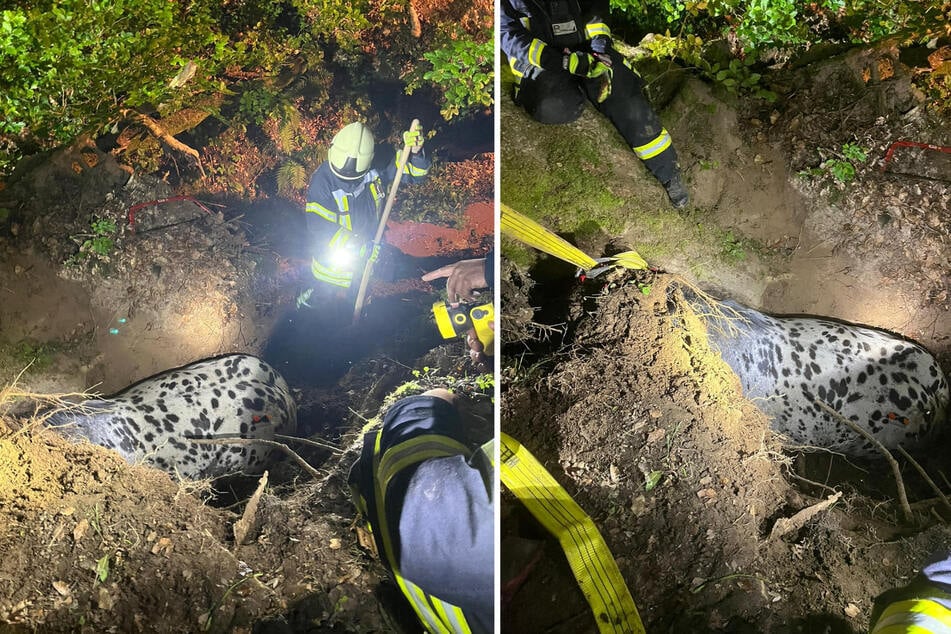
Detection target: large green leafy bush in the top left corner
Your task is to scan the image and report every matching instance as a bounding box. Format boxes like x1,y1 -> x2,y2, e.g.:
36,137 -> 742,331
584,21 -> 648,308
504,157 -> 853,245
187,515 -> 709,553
0,0 -> 240,168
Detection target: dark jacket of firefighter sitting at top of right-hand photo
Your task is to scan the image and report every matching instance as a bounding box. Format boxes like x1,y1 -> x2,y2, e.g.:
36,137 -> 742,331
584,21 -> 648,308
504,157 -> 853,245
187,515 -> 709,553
499,0 -> 611,80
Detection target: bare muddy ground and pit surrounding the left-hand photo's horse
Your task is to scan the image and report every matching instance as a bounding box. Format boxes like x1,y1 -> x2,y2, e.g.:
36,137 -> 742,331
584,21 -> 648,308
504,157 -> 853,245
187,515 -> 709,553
0,127 -> 493,632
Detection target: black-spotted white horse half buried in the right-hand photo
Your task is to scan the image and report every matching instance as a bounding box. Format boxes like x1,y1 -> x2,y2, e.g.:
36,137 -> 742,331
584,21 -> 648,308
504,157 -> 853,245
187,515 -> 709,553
682,288 -> 949,456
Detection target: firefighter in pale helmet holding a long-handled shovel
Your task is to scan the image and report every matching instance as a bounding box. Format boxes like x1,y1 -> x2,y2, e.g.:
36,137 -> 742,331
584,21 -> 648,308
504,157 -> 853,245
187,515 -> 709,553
304,122 -> 430,293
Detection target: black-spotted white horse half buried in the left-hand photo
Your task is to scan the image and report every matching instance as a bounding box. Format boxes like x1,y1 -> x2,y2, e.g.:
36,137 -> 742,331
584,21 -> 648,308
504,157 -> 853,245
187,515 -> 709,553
45,354 -> 297,479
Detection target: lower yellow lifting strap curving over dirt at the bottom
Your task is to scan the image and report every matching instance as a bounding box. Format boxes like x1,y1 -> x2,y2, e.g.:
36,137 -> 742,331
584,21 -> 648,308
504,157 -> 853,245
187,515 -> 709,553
499,433 -> 644,634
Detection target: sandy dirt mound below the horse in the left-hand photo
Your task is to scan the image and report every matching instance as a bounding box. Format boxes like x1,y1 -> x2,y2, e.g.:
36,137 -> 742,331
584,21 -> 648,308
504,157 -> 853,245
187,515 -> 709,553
0,412 -> 278,632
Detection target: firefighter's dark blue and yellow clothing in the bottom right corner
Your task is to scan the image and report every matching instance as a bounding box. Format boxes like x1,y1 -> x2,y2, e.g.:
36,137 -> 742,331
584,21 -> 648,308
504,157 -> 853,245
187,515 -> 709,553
869,554 -> 951,634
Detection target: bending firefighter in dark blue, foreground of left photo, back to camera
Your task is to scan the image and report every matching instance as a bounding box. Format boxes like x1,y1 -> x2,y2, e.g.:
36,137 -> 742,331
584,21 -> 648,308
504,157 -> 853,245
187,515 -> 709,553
349,389 -> 495,634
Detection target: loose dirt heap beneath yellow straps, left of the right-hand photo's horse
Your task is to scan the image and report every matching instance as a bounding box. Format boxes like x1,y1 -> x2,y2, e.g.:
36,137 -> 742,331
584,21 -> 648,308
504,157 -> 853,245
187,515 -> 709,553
502,274 -> 951,633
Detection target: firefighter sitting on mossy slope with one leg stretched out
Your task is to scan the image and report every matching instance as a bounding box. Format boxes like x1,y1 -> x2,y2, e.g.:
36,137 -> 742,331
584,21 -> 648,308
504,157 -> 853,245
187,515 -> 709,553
499,0 -> 689,209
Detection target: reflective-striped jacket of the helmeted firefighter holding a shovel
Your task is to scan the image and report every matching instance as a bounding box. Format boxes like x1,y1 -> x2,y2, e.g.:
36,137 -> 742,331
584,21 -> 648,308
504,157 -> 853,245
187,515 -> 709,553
304,150 -> 430,288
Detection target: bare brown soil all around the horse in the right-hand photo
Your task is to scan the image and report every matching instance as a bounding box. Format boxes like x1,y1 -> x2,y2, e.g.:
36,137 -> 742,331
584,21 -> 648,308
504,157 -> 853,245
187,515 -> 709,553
501,43 -> 951,633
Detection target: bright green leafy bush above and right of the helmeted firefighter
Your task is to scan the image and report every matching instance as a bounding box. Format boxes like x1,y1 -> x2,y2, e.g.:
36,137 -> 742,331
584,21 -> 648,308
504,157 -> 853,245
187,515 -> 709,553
406,31 -> 495,121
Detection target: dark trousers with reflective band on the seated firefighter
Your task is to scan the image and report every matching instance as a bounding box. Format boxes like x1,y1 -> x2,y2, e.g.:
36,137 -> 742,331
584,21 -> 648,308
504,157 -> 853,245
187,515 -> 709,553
515,49 -> 677,184
